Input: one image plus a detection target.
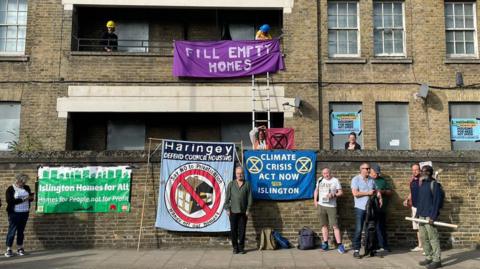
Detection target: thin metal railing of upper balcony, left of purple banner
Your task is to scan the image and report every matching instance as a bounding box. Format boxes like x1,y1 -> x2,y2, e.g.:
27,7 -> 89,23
73,36 -> 173,56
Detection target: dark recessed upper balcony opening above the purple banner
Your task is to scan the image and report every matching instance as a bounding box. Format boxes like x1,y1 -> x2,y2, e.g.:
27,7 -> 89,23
71,6 -> 283,57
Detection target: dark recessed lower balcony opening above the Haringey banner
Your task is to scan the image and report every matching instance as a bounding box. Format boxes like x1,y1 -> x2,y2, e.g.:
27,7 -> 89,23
67,113 -> 283,151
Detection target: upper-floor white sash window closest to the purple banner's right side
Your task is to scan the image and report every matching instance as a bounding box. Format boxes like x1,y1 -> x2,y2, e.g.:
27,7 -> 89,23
328,1 -> 360,57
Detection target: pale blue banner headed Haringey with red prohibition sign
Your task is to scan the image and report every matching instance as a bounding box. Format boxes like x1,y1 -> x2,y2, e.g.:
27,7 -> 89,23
155,140 -> 235,232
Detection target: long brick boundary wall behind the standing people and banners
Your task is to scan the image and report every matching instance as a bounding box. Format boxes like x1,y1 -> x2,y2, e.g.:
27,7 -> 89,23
0,151 -> 480,249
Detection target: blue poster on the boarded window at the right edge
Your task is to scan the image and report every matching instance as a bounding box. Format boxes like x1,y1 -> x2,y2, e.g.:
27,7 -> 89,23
450,118 -> 480,142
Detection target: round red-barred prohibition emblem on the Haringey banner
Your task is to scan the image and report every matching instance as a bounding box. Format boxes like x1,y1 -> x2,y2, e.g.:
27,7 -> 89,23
164,163 -> 225,228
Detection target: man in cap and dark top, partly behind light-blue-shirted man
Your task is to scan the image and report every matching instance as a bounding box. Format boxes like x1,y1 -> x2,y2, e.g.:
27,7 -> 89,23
370,163 -> 392,252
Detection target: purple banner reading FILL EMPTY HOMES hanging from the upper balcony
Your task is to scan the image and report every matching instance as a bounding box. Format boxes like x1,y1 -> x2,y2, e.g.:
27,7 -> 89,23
173,39 -> 284,78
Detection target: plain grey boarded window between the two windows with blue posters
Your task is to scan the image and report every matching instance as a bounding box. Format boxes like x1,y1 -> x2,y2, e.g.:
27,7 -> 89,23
377,103 -> 410,150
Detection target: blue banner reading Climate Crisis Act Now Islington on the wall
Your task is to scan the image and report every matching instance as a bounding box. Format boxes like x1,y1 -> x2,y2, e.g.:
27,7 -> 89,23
244,150 -> 317,200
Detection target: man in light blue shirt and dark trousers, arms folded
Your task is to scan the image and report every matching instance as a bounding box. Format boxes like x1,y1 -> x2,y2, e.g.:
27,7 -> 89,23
351,163 -> 382,259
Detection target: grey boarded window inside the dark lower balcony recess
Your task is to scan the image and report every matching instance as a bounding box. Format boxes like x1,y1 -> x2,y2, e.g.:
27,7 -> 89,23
107,120 -> 145,150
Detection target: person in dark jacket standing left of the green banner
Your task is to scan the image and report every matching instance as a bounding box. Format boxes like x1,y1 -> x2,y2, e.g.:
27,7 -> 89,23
5,174 -> 34,257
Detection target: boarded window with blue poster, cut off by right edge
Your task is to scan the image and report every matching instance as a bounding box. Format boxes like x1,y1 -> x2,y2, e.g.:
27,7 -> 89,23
450,103 -> 480,150
